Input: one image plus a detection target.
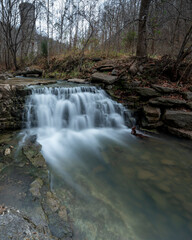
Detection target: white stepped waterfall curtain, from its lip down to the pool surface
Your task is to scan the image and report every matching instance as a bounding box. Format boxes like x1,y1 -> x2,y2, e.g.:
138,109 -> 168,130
26,87 -> 134,131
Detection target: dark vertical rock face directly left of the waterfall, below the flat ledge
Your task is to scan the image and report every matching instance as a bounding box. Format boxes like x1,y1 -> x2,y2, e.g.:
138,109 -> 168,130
0,84 -> 29,131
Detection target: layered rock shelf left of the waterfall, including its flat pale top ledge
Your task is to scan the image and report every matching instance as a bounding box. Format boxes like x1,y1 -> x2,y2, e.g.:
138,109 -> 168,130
0,78 -> 56,132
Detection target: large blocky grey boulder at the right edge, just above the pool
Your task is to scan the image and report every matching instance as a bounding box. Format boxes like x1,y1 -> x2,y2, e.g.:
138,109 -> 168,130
163,110 -> 192,130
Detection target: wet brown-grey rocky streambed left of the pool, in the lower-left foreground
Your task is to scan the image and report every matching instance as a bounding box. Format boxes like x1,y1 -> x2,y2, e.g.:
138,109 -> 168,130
0,133 -> 72,240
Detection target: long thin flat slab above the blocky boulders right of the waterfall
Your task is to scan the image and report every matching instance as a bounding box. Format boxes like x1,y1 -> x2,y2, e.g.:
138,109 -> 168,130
149,97 -> 186,108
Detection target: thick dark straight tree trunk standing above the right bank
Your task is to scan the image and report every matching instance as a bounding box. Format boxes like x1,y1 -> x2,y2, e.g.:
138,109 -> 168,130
136,0 -> 151,57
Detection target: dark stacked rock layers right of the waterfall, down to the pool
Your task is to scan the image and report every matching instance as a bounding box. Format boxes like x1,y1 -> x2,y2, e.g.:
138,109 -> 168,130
92,72 -> 192,139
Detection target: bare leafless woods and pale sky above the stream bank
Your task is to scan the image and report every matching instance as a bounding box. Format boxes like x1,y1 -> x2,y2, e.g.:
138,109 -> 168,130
0,0 -> 192,69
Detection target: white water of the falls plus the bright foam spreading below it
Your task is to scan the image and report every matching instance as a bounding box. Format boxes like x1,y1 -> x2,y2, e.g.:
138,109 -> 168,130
26,87 -> 132,182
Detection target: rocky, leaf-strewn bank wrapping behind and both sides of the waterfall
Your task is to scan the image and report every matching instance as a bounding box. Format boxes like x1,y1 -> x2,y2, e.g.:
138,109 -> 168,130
0,58 -> 192,139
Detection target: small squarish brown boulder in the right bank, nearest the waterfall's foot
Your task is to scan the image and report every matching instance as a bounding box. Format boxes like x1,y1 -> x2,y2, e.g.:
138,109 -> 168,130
143,106 -> 161,123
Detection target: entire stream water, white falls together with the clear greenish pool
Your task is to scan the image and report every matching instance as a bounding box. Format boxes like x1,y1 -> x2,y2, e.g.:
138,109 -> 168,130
26,84 -> 192,240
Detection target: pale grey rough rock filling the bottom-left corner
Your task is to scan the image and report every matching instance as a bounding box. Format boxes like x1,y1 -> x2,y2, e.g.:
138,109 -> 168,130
0,208 -> 55,240
